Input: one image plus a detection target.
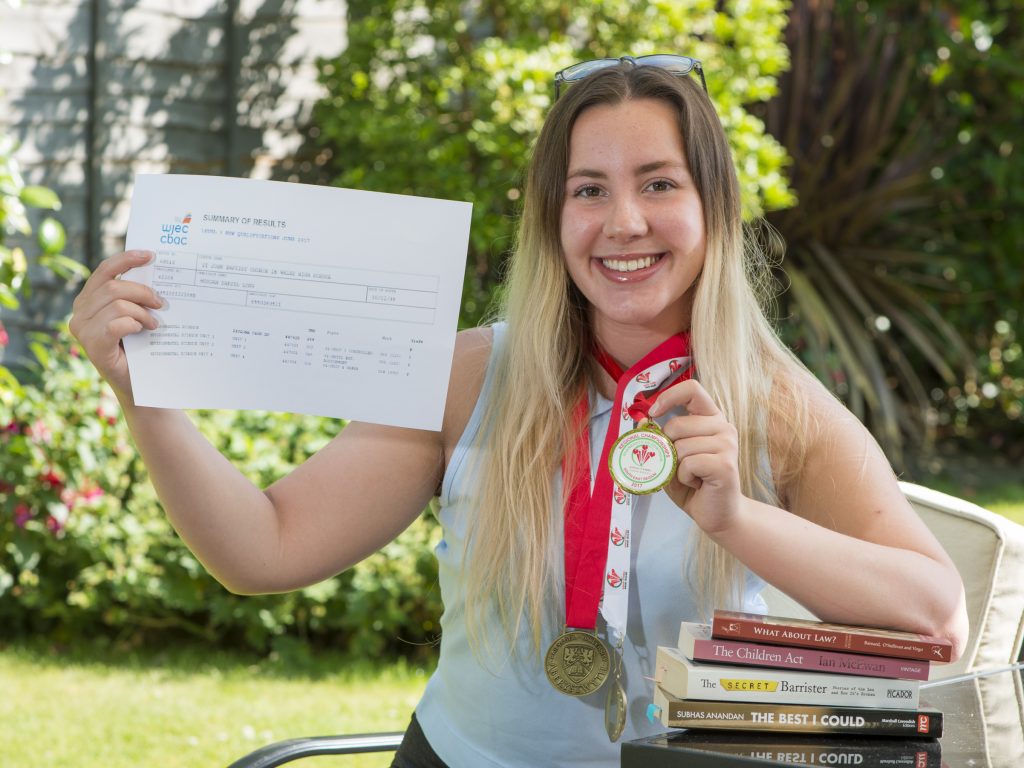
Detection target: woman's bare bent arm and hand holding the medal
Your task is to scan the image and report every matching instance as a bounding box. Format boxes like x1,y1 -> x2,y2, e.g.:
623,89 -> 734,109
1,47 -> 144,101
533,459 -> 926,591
654,382 -> 968,654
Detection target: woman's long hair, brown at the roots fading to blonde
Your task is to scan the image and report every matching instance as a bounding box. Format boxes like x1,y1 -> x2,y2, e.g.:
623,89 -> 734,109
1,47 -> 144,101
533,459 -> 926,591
466,65 -> 801,651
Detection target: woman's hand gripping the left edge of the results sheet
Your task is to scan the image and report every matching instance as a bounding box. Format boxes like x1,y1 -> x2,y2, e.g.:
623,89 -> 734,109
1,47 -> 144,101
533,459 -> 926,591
70,251 -> 164,401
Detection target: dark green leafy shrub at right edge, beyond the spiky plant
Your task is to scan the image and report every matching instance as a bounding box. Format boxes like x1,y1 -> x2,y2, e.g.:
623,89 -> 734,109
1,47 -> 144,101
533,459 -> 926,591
914,0 -> 1024,456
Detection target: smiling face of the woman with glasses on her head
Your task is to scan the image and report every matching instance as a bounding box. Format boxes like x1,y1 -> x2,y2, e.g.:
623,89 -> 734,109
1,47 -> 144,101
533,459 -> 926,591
560,98 -> 706,356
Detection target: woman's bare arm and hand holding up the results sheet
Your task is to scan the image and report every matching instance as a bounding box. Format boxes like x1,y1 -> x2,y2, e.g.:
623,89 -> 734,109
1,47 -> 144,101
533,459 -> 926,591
71,253 -> 489,593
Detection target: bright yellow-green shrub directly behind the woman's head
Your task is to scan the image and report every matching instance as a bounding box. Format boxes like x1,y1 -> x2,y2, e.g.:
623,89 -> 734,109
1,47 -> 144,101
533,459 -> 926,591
315,0 -> 793,325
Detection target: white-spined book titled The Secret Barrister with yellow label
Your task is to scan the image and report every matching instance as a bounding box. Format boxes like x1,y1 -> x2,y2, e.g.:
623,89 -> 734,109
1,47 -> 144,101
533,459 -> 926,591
654,645 -> 921,710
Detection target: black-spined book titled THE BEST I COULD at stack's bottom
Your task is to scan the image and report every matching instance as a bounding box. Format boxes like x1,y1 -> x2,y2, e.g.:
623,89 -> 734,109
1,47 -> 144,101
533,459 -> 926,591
647,686 -> 942,738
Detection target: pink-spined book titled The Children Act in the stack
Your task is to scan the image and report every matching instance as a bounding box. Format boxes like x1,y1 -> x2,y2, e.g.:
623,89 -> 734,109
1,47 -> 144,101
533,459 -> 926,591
679,622 -> 930,680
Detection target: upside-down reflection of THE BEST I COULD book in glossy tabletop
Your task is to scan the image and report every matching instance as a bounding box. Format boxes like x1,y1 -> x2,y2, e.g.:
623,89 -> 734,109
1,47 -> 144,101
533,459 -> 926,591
622,731 -> 942,768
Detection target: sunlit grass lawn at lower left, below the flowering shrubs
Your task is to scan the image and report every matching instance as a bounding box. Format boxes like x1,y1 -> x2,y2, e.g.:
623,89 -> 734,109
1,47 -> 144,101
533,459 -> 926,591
0,644 -> 429,768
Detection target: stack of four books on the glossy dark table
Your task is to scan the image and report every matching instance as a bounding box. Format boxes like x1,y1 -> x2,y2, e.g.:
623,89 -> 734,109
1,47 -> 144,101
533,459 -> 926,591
648,610 -> 952,768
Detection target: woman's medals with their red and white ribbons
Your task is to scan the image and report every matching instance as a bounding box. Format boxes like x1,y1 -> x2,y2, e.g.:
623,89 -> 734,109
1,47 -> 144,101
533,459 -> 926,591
545,334 -> 693,740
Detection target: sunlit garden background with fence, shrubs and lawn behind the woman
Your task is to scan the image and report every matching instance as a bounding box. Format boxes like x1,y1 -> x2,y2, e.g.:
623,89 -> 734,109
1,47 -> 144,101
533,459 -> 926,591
0,0 -> 1024,768
